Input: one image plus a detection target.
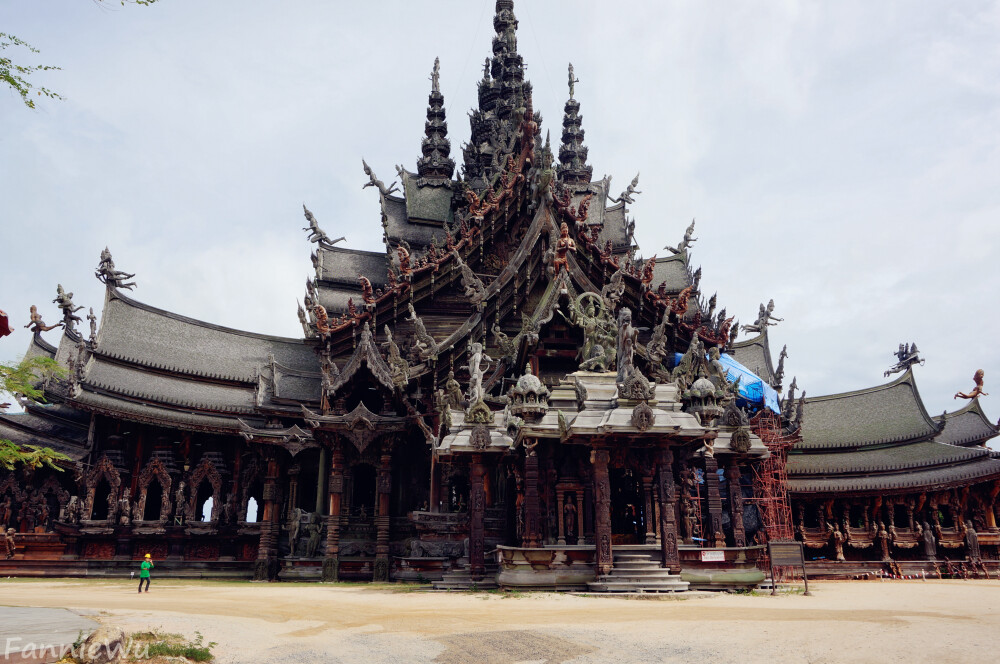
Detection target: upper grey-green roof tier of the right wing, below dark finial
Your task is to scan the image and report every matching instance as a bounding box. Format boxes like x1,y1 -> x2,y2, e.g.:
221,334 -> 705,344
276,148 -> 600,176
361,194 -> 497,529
795,371 -> 940,450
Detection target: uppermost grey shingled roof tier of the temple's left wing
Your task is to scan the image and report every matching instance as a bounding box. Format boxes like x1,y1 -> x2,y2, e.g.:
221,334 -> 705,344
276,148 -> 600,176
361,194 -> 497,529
97,289 -> 318,383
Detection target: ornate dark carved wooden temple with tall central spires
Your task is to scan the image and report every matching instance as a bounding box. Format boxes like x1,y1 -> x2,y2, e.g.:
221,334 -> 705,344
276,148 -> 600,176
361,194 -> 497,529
0,0 -> 1000,591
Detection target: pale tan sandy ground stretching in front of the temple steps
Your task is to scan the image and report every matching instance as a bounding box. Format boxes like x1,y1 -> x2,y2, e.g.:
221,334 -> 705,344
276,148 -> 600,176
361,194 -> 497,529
0,579 -> 1000,664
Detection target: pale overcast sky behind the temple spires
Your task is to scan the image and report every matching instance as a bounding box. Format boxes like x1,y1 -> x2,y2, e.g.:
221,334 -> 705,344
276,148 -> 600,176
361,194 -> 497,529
0,0 -> 1000,426
